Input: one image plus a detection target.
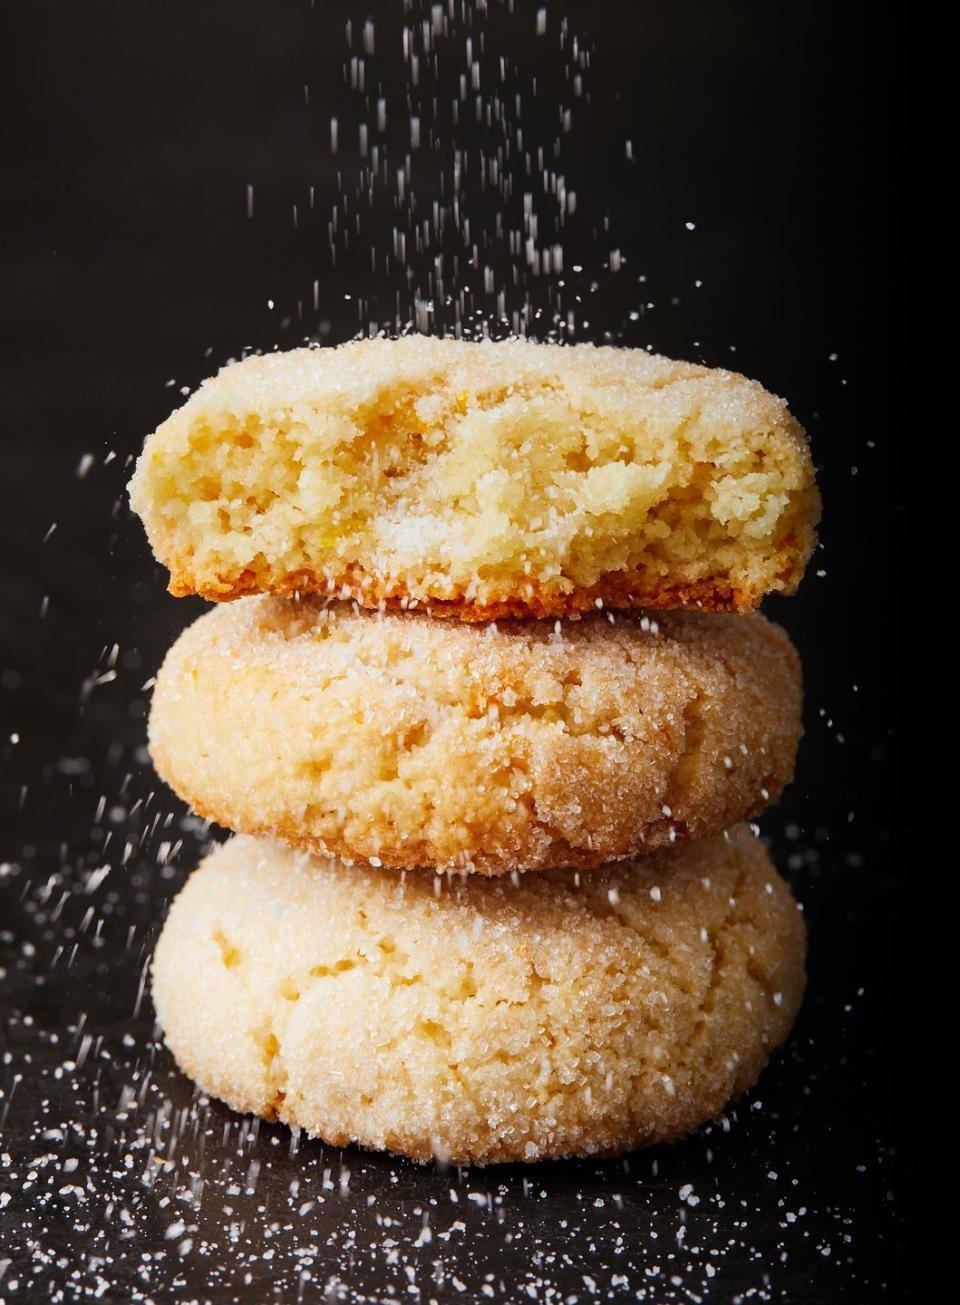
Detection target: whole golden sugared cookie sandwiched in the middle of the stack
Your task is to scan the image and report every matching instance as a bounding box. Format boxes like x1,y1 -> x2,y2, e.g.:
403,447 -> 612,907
150,598 -> 801,874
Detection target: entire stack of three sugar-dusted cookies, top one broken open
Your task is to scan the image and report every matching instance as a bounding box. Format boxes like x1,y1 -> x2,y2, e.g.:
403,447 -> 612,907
132,337 -> 818,1163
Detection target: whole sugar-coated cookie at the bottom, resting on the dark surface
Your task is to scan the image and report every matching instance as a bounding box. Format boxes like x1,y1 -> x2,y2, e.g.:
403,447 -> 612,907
153,826 -> 805,1163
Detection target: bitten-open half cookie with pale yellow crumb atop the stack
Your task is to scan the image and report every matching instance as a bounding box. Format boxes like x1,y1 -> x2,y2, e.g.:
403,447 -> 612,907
130,337 -> 819,620
